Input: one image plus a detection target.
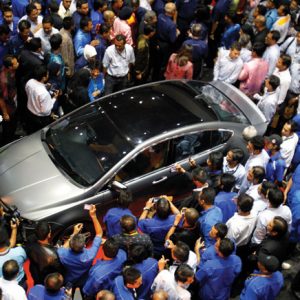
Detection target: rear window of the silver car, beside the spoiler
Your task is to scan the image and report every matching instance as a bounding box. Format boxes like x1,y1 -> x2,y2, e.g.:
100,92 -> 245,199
188,81 -> 249,124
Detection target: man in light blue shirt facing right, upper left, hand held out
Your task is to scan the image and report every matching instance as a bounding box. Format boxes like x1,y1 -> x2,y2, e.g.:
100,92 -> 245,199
74,17 -> 99,58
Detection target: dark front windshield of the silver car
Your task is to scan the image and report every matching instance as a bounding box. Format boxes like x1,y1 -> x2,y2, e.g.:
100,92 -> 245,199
45,102 -> 133,186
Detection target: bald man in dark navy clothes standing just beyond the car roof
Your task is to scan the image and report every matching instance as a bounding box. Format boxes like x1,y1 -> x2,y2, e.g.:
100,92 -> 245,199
153,2 -> 180,80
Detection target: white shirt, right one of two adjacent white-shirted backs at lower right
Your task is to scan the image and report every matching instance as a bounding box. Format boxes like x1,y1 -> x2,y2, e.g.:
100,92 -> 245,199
251,205 -> 292,244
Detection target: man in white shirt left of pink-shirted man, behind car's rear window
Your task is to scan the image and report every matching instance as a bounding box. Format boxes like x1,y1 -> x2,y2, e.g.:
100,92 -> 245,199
214,42 -> 243,84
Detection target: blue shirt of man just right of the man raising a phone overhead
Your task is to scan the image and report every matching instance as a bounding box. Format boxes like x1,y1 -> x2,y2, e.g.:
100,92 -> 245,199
83,249 -> 126,296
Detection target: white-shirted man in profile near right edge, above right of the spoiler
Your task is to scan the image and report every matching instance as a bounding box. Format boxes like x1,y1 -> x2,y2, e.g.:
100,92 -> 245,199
273,54 -> 292,105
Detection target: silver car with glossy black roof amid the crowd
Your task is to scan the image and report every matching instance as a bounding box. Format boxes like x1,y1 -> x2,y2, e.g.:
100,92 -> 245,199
0,80 -> 267,239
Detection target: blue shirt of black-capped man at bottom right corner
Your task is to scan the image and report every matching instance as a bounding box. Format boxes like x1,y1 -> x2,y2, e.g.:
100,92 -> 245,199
240,271 -> 284,300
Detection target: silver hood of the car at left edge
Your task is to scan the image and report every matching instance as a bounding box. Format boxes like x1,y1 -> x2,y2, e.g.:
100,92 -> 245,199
0,132 -> 85,219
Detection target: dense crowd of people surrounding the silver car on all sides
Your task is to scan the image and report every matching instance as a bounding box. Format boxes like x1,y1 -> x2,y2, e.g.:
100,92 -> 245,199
0,0 -> 300,300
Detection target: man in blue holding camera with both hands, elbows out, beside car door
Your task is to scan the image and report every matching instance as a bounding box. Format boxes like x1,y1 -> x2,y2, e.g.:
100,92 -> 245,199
138,196 -> 180,257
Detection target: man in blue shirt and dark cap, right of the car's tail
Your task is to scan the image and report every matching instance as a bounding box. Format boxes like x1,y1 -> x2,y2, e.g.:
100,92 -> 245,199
266,134 -> 286,186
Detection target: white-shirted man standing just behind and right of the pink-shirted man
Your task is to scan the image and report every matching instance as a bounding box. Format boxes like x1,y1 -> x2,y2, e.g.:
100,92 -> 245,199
263,30 -> 280,76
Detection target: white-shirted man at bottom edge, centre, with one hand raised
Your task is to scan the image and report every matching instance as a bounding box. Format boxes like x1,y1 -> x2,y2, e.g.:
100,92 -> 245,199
151,257 -> 194,300
